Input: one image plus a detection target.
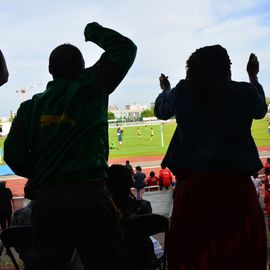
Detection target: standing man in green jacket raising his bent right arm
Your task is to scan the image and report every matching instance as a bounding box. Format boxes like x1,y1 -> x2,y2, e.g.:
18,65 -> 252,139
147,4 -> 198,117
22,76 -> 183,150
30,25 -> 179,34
4,23 -> 136,270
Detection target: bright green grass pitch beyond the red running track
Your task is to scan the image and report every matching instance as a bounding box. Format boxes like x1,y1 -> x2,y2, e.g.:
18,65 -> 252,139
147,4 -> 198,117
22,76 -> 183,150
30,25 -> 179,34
0,119 -> 270,164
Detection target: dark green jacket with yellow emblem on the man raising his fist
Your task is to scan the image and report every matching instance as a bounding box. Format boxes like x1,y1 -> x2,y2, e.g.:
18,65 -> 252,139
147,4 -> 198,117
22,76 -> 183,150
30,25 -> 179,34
4,23 -> 136,189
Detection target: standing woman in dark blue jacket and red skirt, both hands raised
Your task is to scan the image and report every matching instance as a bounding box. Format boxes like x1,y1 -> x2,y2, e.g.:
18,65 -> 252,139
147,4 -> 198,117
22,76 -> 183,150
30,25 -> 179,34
155,45 -> 267,270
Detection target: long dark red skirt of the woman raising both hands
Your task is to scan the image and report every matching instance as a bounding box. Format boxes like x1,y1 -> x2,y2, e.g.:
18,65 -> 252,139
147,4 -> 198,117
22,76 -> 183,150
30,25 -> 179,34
167,173 -> 267,270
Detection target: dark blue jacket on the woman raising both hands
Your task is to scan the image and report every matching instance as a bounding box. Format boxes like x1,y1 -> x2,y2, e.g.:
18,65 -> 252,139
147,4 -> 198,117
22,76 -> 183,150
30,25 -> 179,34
155,80 -> 267,172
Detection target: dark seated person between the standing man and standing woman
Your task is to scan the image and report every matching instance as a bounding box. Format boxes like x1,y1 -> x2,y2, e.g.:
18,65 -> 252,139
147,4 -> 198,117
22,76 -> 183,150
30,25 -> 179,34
107,164 -> 157,270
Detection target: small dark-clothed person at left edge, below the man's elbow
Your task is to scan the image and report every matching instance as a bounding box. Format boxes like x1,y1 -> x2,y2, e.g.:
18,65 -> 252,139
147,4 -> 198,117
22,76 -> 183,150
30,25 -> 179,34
0,181 -> 13,230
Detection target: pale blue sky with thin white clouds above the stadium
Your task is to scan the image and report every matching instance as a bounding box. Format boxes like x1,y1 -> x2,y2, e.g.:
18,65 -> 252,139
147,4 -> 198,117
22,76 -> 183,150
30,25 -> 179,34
0,0 -> 270,116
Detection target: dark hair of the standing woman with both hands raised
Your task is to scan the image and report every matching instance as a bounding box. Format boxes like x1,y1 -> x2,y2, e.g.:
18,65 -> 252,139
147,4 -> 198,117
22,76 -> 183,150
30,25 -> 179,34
186,45 -> 231,104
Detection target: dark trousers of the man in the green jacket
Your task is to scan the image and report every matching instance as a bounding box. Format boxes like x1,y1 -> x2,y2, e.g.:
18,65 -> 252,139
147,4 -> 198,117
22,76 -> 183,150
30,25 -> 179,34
29,183 -> 127,270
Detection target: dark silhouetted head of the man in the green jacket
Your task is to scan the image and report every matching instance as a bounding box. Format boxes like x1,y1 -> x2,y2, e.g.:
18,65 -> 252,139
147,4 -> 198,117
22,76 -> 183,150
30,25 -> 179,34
49,44 -> 85,79
